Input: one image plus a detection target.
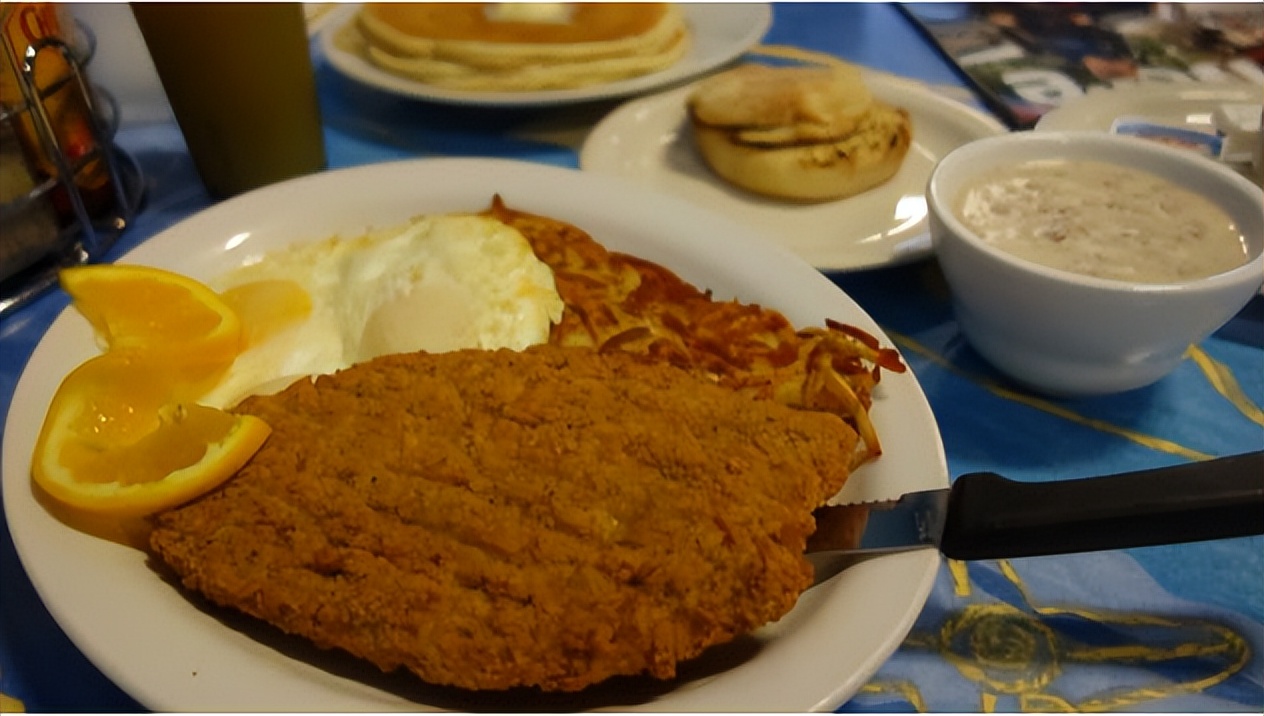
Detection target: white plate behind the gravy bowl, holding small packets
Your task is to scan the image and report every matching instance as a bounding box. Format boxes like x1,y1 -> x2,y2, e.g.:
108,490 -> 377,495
1035,82 -> 1264,132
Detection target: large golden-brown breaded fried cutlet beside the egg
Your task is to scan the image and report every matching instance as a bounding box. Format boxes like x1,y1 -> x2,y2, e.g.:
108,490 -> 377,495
152,345 -> 857,691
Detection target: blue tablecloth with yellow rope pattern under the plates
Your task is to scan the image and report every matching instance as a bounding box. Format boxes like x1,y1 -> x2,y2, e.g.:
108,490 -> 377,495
0,4 -> 1264,712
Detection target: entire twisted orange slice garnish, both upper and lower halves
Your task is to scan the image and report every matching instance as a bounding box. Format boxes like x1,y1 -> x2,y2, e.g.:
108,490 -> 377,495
32,264 -> 270,517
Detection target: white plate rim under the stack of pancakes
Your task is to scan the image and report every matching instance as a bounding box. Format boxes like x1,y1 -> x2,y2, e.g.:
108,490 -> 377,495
320,3 -> 772,108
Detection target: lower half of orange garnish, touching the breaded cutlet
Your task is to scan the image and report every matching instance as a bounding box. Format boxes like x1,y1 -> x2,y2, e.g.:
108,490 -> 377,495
32,350 -> 270,517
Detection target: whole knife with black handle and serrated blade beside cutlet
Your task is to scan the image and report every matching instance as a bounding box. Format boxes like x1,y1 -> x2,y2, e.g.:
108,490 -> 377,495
808,450 -> 1264,569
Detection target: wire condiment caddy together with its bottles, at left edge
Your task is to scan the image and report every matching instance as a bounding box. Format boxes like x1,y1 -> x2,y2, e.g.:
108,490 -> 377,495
0,3 -> 142,316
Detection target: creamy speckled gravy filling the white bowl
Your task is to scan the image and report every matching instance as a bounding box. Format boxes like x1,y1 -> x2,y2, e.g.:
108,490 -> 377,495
954,159 -> 1249,283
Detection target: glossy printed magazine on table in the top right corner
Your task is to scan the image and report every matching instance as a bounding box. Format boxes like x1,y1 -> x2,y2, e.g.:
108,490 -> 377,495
901,3 -> 1264,129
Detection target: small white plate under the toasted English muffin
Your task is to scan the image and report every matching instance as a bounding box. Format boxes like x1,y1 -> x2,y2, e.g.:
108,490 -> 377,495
579,73 -> 1005,271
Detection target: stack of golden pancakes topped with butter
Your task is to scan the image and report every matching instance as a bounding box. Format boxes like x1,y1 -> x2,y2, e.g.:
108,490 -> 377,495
351,3 -> 689,92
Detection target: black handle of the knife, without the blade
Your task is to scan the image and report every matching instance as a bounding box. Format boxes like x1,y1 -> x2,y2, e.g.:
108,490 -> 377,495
940,452 -> 1264,559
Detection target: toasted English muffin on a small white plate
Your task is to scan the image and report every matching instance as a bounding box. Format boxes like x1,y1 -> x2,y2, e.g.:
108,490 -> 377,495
688,65 -> 913,201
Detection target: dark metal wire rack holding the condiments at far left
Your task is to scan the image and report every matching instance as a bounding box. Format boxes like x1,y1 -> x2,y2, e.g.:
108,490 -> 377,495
0,23 -> 143,316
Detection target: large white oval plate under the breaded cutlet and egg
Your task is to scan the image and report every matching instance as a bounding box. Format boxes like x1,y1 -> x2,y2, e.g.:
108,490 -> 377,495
3,158 -> 948,712
